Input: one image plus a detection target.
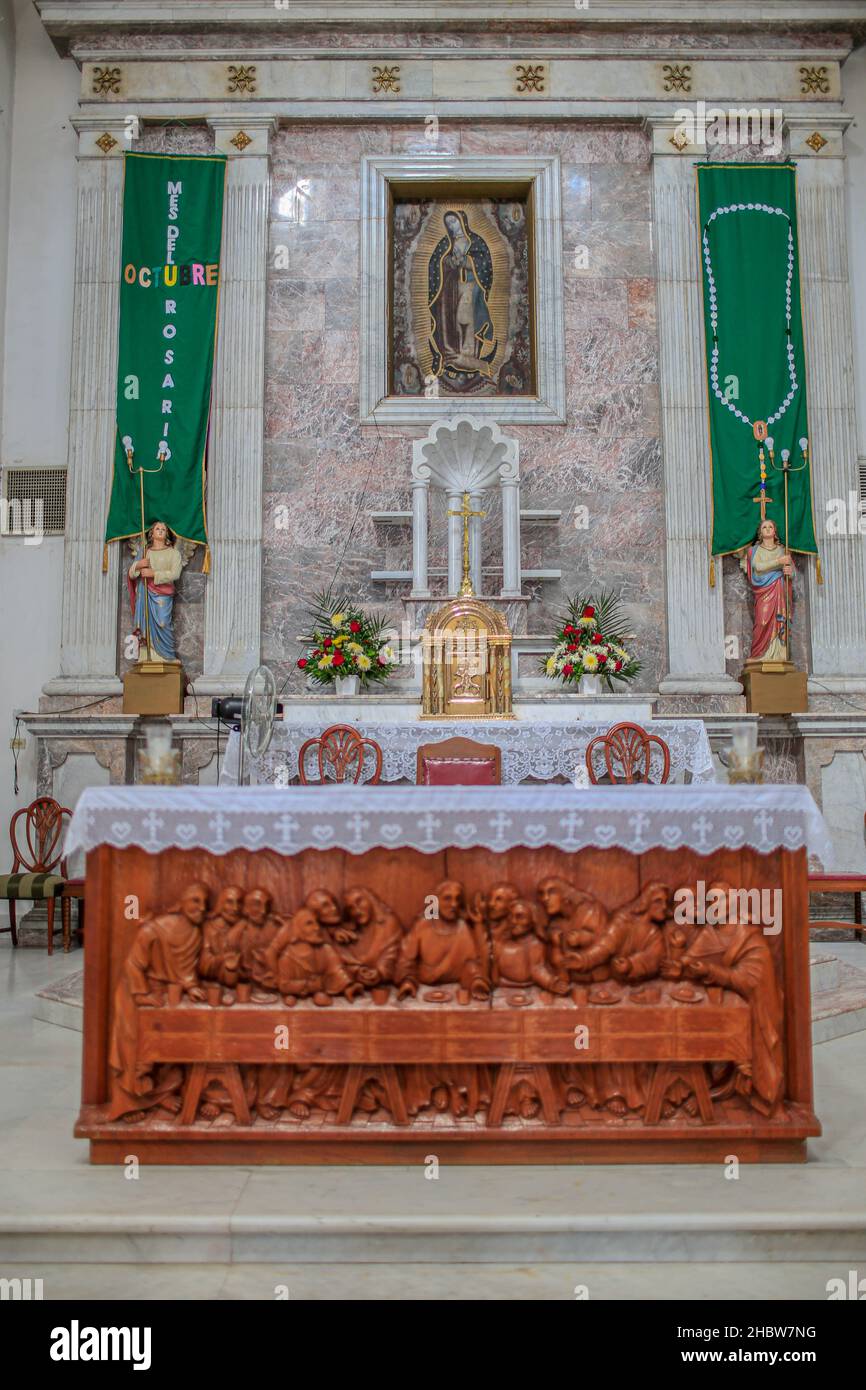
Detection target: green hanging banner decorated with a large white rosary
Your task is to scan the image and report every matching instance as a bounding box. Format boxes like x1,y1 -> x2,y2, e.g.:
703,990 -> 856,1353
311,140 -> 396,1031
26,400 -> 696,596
696,164 -> 817,555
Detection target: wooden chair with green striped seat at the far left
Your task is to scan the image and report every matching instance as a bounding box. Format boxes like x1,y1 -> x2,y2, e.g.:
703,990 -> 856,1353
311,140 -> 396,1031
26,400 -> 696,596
0,796 -> 72,955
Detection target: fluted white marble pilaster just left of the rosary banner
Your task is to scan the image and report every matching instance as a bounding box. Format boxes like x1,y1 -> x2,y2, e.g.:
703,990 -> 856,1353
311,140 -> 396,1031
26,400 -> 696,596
646,117 -> 742,696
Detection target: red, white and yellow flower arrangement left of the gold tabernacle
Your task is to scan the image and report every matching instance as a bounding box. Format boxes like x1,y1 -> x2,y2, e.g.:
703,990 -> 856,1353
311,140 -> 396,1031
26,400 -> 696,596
297,589 -> 396,685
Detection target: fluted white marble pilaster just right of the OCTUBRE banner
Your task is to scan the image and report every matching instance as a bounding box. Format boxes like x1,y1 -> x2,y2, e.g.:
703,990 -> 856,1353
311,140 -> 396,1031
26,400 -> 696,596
195,115 -> 275,695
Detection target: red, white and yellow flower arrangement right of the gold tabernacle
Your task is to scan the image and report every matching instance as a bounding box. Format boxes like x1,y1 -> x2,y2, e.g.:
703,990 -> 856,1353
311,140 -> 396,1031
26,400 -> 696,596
542,589 -> 641,691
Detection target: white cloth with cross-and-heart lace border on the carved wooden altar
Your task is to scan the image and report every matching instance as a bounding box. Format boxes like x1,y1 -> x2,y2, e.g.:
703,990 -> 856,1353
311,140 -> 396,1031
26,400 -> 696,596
65,783 -> 833,866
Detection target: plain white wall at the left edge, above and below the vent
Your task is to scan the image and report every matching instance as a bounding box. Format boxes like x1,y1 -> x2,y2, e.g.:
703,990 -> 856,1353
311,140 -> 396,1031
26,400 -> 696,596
0,0 -> 79,839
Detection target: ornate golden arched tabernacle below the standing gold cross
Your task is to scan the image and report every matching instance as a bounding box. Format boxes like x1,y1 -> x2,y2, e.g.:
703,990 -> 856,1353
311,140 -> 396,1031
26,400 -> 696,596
421,598 -> 514,719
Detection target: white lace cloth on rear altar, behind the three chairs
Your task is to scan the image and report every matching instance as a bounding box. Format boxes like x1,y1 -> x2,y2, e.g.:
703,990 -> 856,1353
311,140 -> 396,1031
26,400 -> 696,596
220,719 -> 714,787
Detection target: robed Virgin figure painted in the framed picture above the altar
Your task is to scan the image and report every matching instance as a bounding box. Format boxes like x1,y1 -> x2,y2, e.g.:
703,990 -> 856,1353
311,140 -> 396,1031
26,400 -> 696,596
428,210 -> 498,391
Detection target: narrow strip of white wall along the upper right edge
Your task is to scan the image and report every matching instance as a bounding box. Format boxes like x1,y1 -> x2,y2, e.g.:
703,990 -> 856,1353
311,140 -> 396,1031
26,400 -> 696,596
842,46 -> 866,455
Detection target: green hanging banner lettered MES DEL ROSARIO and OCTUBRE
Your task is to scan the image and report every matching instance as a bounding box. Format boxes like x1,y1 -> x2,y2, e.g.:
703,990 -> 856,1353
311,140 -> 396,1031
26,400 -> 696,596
106,154 -> 225,558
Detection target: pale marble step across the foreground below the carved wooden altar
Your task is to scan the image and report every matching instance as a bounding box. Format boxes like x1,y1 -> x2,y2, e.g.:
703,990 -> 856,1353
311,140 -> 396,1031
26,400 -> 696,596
0,1167 -> 866,1270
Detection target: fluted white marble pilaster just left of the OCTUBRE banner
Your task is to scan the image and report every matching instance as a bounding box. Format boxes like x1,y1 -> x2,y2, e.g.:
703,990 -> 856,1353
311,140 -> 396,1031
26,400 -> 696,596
44,119 -> 128,695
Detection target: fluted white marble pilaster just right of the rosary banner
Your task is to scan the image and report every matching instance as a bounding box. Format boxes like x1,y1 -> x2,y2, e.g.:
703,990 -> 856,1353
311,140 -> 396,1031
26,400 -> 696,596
785,113 -> 866,695
